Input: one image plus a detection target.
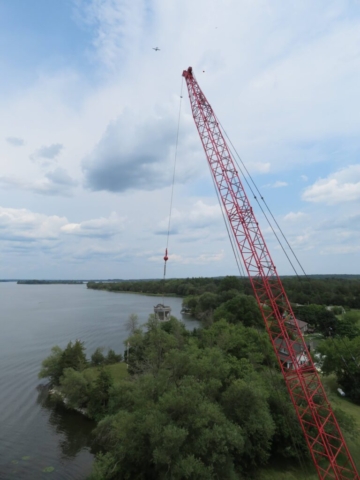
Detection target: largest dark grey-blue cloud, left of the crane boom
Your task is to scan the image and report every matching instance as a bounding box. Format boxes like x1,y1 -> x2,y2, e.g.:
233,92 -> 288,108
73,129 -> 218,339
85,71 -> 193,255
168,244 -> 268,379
84,110 -> 175,192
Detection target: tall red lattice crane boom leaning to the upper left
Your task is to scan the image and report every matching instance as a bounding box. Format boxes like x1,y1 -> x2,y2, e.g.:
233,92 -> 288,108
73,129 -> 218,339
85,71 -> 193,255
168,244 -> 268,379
183,67 -> 360,480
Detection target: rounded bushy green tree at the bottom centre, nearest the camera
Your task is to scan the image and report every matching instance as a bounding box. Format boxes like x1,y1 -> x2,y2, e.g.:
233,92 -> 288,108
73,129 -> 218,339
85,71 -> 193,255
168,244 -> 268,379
92,377 -> 244,480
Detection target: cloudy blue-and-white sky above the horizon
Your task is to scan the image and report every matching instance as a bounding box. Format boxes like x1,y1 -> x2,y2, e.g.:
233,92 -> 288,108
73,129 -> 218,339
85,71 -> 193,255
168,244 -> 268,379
0,0 -> 360,279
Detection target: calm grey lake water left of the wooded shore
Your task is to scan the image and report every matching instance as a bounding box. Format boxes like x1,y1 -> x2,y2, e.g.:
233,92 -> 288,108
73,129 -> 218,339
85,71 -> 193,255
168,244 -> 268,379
0,283 -> 198,480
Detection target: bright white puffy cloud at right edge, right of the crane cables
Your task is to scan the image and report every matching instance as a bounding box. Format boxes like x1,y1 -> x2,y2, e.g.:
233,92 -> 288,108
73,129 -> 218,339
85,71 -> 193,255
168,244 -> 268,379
303,165 -> 360,205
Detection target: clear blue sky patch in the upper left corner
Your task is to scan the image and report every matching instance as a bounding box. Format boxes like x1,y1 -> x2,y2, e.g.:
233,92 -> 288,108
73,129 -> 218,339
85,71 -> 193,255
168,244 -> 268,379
0,0 -> 94,93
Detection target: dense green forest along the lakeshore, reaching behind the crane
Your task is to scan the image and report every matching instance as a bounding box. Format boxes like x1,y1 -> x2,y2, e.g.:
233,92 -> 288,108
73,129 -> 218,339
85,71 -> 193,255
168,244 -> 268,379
40,277 -> 360,480
